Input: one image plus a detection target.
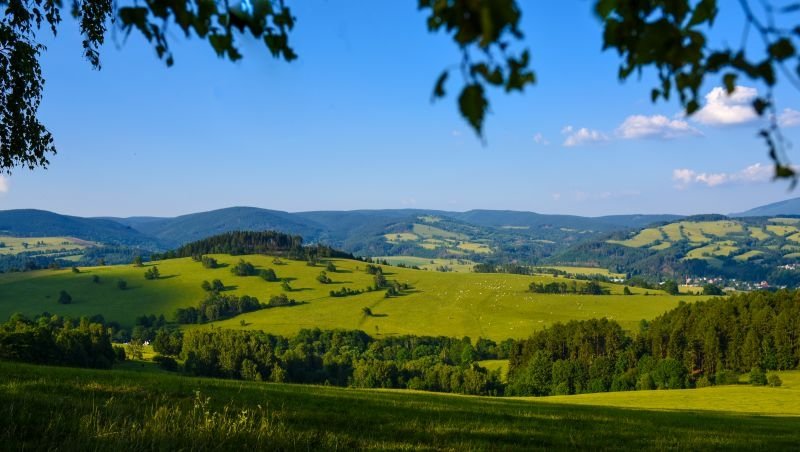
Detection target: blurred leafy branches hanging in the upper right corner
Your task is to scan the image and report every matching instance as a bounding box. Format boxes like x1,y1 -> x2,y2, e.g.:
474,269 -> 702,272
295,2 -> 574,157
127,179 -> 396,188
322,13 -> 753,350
595,0 -> 800,183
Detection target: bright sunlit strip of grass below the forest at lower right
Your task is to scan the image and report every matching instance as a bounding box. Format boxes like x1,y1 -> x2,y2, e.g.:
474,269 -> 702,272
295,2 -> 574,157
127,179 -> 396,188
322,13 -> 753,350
536,371 -> 800,416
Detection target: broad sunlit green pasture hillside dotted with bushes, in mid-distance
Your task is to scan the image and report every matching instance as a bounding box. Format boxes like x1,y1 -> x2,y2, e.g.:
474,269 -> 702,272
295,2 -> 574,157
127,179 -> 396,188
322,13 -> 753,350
0,255 -> 700,340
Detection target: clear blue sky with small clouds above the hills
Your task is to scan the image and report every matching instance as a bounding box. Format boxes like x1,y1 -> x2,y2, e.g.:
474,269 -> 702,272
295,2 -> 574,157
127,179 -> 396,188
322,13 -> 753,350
0,0 -> 800,216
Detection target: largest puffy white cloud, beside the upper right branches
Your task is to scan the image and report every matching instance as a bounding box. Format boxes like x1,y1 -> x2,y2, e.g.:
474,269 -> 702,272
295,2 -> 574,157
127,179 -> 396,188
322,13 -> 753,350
692,86 -> 758,126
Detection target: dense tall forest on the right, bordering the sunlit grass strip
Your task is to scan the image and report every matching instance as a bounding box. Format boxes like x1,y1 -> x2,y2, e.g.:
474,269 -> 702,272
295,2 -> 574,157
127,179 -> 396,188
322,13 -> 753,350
508,291 -> 800,395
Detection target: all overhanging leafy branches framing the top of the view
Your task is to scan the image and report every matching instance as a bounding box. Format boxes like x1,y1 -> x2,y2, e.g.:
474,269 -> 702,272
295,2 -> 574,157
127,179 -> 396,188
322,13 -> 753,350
0,0 -> 800,179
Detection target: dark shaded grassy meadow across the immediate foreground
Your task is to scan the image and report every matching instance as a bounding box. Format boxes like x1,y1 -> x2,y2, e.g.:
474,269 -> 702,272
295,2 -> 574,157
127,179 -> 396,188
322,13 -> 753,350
0,363 -> 800,450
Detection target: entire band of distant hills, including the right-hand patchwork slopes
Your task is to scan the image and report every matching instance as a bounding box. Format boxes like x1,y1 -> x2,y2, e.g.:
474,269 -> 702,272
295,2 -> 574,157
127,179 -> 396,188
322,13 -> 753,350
0,198 -> 800,284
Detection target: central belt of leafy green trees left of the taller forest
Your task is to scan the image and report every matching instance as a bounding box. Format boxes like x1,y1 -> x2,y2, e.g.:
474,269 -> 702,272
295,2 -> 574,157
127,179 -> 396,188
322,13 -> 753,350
181,329 -> 503,395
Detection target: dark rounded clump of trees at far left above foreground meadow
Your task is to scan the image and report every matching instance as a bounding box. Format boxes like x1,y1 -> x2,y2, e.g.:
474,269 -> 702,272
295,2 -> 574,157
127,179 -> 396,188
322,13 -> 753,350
0,314 -> 124,369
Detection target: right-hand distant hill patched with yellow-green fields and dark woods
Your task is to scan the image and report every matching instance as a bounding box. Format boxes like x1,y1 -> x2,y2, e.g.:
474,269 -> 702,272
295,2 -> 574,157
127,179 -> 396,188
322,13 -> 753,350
551,215 -> 800,286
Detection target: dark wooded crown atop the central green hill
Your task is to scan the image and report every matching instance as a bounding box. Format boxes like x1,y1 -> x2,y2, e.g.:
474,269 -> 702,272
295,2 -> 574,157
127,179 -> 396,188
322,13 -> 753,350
152,231 -> 353,265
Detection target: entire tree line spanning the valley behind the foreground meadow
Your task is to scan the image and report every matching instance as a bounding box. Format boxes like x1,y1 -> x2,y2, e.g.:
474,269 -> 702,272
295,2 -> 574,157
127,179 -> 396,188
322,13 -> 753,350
0,291 -> 800,396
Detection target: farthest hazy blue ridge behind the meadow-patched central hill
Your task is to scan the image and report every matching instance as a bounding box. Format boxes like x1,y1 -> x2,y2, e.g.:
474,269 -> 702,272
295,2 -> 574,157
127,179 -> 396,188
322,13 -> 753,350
0,198 -> 800,251
